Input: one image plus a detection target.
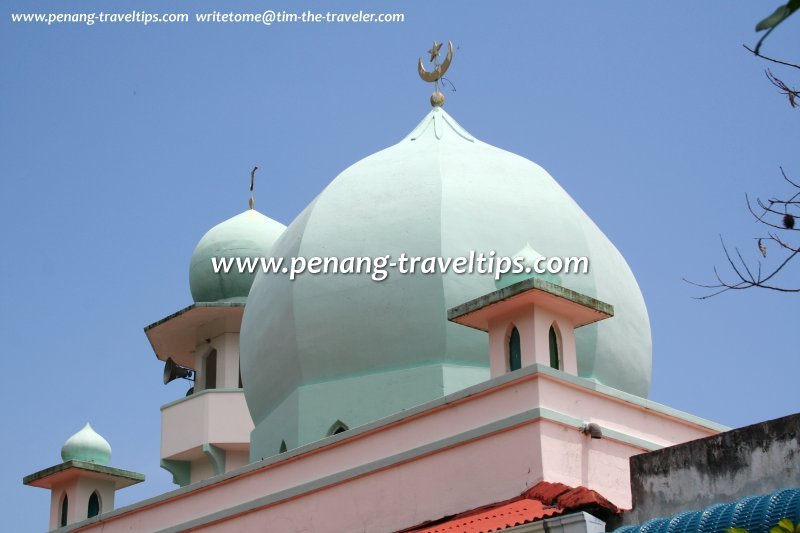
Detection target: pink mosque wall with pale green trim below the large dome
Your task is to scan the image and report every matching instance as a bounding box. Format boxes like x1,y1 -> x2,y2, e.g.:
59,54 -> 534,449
76,371 -> 716,533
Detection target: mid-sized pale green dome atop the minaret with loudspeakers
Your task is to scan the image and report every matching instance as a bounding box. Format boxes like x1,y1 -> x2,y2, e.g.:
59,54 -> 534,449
189,209 -> 286,302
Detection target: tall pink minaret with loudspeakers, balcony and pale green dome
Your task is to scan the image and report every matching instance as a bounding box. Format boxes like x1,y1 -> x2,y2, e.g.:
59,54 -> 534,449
144,167 -> 286,486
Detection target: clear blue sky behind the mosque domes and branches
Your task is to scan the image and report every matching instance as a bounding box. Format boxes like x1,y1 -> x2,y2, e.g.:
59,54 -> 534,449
0,0 -> 800,531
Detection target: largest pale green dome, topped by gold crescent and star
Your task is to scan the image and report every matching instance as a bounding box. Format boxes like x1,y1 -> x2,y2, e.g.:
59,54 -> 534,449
241,107 -> 652,436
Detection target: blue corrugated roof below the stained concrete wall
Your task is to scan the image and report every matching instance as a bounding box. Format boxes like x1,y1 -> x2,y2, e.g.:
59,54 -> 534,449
614,489 -> 800,533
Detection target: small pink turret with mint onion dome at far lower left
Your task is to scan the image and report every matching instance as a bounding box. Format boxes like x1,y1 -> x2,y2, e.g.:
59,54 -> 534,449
22,423 -> 144,530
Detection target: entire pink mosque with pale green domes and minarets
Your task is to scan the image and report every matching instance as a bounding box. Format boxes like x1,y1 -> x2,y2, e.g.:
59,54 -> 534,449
23,39 -> 800,533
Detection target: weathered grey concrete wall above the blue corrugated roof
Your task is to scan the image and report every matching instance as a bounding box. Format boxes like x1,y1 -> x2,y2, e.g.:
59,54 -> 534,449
623,413 -> 800,524
